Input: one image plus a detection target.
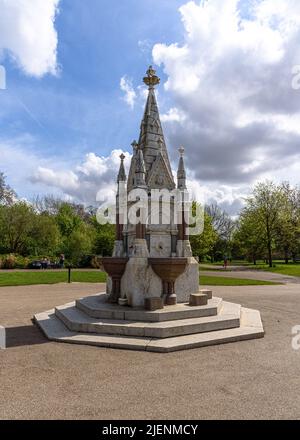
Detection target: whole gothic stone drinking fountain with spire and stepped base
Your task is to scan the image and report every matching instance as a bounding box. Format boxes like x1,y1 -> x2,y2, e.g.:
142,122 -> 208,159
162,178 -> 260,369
34,67 -> 264,353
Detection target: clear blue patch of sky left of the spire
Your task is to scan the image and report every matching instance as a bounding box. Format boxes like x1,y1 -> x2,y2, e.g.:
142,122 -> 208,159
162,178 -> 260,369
0,0 -> 183,160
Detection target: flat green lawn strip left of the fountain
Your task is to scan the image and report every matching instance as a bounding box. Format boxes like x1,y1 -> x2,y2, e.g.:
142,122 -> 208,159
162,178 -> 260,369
0,270 -> 106,286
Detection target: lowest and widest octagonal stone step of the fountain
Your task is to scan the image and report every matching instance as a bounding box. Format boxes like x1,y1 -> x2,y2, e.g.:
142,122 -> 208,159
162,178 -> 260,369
34,308 -> 264,353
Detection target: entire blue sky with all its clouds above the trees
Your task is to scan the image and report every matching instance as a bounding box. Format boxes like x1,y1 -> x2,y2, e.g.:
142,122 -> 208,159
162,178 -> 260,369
0,0 -> 300,215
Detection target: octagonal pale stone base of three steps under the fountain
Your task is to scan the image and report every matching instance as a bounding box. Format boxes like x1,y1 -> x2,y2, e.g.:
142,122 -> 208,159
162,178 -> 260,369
34,294 -> 264,353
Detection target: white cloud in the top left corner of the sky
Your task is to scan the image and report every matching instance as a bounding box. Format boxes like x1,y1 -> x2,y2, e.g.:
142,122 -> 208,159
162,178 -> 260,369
0,0 -> 60,77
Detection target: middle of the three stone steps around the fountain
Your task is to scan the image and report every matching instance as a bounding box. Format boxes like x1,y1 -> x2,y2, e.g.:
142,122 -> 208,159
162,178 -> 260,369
55,302 -> 241,338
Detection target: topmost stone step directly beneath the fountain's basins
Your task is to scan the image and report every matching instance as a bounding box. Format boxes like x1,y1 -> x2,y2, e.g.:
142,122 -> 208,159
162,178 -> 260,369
76,293 -> 222,322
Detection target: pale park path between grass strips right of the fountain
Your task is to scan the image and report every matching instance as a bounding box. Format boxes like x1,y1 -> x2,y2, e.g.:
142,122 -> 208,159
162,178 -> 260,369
200,266 -> 300,284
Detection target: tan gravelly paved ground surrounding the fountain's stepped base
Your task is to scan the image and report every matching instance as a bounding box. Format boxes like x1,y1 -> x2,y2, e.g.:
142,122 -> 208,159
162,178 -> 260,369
0,284 -> 300,420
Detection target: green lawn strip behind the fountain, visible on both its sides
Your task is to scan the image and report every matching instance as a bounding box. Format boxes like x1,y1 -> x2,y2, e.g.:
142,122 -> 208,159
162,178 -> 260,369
0,270 -> 274,287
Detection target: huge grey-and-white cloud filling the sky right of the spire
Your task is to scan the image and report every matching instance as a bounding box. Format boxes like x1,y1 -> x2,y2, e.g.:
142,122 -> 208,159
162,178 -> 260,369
153,0 -> 300,191
